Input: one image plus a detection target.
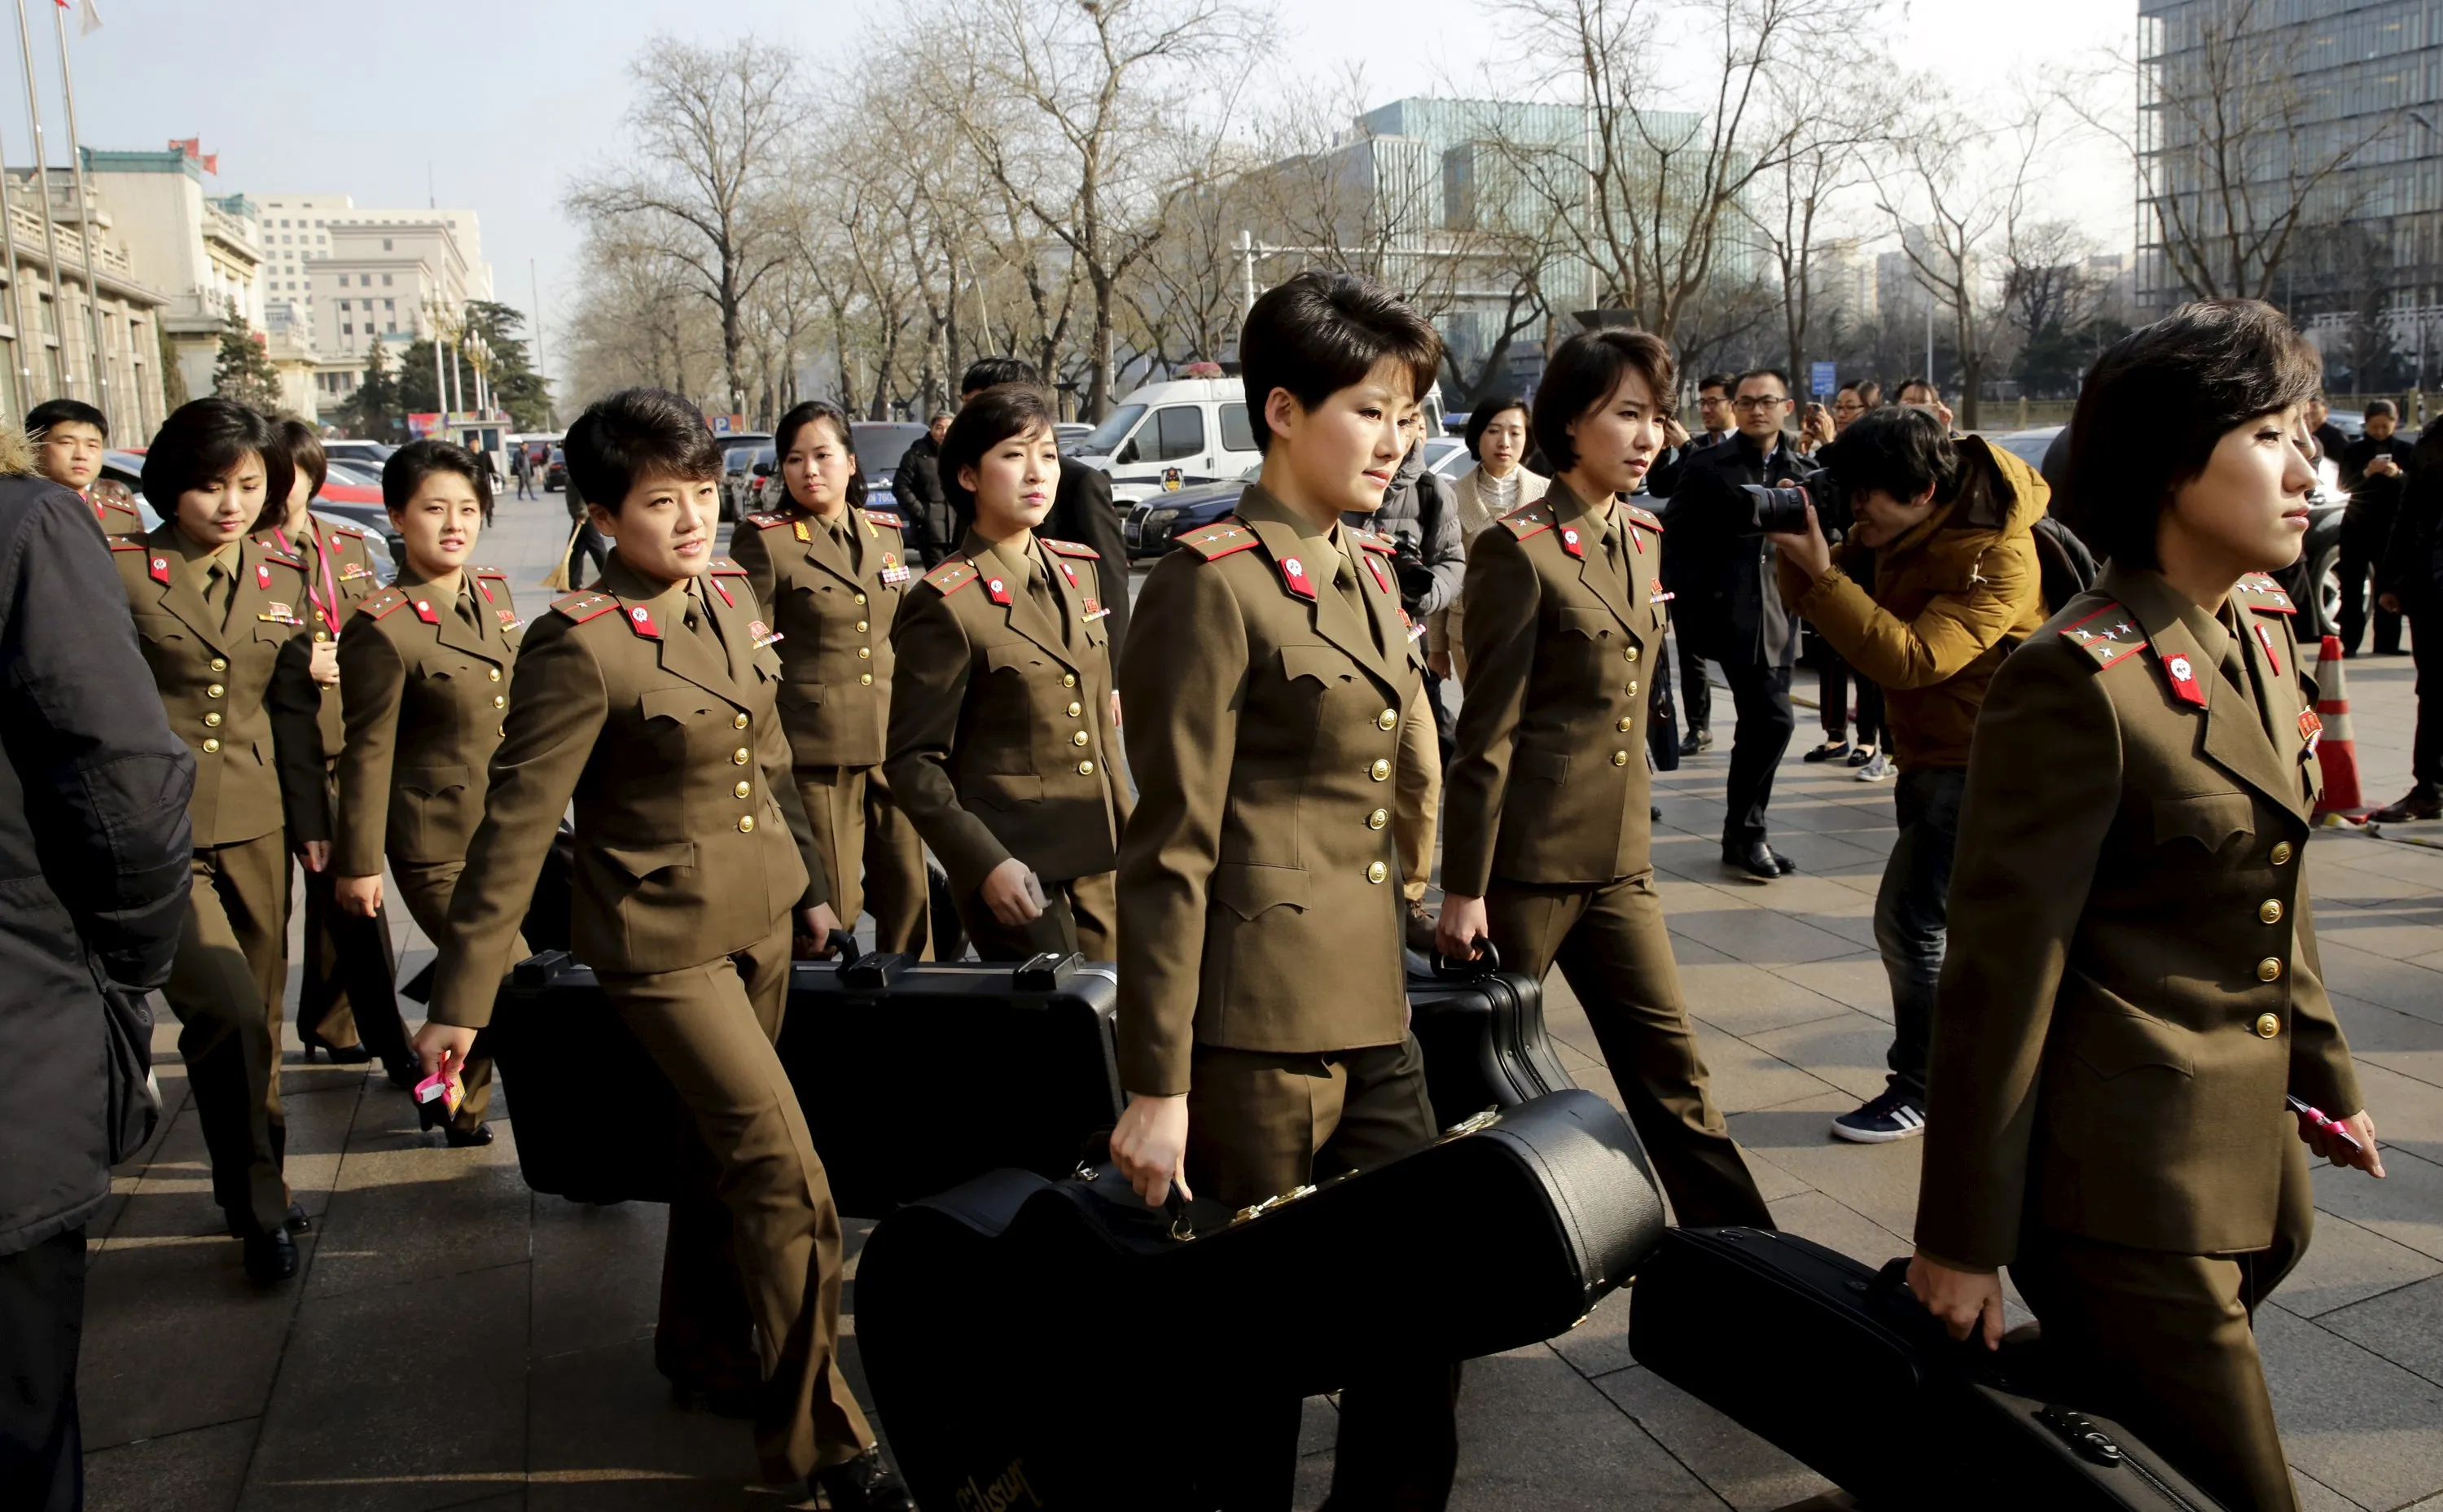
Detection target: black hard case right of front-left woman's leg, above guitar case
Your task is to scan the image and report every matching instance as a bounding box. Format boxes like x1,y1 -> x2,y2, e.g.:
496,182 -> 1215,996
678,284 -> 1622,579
777,955 -> 1121,1219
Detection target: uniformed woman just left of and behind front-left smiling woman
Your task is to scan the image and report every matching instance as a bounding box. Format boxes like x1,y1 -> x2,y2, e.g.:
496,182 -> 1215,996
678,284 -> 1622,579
330,440 -> 525,1146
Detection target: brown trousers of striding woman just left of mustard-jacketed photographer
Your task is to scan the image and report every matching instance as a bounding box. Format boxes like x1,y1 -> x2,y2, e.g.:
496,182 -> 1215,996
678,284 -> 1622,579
1485,872 -> 1774,1229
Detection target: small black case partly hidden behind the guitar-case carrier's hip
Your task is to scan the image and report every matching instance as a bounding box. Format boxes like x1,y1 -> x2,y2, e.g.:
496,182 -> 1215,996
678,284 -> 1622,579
1407,940 -> 1578,1129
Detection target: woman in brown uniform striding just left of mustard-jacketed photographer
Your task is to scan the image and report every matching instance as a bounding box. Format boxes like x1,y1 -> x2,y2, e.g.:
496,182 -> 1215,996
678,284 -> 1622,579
1436,330 -> 1774,1229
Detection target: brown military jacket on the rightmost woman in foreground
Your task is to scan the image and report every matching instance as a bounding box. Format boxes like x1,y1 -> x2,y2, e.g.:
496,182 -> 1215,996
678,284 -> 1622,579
1918,569 -> 2362,1268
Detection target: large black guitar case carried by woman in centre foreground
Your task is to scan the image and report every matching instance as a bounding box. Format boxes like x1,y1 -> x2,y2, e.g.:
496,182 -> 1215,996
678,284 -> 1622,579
857,1092 -> 1664,1512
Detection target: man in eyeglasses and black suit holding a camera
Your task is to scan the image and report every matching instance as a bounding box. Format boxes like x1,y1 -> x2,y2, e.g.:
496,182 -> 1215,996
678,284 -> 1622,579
1664,369 -> 1815,882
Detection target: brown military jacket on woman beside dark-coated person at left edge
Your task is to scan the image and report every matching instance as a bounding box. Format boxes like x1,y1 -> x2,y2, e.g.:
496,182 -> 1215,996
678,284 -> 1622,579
110,523 -> 330,848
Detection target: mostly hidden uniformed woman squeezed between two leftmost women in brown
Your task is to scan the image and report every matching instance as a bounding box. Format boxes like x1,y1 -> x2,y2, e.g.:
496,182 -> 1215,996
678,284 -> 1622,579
264,420 -> 415,1087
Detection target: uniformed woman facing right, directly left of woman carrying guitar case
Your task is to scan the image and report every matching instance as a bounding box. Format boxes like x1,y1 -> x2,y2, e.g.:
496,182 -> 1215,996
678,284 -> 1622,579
884,383 -> 1129,960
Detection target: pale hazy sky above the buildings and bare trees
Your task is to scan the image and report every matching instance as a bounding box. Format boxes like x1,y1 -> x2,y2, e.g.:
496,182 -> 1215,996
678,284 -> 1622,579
42,0 -> 2135,376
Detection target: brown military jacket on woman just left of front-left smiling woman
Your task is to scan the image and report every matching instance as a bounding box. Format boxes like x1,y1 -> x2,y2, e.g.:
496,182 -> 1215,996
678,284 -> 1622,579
332,567 -> 525,877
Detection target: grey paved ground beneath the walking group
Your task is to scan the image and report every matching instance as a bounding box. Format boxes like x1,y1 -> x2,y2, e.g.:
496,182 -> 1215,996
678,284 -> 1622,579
81,496 -> 2443,1512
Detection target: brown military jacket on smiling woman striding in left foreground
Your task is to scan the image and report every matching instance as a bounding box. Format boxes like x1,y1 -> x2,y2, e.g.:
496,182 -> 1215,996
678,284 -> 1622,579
432,552 -> 826,1028
